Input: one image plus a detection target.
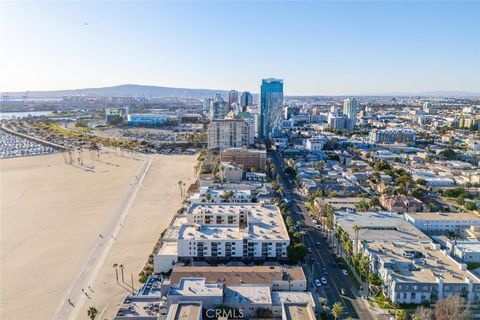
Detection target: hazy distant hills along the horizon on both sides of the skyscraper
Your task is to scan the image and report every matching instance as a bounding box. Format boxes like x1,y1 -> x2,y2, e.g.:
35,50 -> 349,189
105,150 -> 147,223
1,84 -> 480,99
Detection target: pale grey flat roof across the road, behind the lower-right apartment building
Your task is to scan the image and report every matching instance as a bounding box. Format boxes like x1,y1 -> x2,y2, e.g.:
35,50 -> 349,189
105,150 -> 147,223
335,212 -> 431,242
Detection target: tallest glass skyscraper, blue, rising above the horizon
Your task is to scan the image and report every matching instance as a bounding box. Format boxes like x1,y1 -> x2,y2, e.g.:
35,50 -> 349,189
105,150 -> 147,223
259,78 -> 283,140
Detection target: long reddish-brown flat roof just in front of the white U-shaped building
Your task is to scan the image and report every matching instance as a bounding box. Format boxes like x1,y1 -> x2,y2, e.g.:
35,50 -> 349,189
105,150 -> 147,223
170,266 -> 306,285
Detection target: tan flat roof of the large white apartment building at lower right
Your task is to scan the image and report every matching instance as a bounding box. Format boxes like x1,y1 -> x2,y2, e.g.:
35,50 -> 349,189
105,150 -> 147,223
368,242 -> 480,284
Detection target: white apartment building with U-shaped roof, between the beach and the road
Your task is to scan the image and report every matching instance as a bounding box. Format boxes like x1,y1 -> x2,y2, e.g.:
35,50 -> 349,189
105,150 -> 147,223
178,203 -> 290,260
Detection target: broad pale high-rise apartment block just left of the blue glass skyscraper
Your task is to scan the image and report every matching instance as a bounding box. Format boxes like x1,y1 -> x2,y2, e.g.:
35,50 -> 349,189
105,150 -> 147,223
207,119 -> 253,149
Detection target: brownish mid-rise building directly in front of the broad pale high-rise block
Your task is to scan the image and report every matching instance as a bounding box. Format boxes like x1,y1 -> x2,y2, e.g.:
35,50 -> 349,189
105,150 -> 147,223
220,148 -> 267,172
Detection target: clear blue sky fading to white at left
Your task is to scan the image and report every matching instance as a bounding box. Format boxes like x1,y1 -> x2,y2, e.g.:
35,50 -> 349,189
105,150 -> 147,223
0,1 -> 480,95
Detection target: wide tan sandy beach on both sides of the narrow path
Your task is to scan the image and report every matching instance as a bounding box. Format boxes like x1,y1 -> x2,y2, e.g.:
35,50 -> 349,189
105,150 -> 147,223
0,151 -> 196,319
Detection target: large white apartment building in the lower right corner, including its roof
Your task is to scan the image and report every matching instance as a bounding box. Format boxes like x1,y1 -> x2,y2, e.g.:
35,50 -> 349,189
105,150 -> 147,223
366,241 -> 480,304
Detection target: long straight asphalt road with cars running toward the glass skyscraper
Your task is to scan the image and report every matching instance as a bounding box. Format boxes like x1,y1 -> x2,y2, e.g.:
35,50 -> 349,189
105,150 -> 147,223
270,151 -> 374,320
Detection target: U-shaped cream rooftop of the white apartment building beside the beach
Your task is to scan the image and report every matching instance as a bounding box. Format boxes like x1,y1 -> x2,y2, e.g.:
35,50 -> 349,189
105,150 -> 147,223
179,203 -> 290,240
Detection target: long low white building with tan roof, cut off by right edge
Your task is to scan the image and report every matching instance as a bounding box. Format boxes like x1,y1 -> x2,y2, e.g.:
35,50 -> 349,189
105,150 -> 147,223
404,212 -> 480,234
